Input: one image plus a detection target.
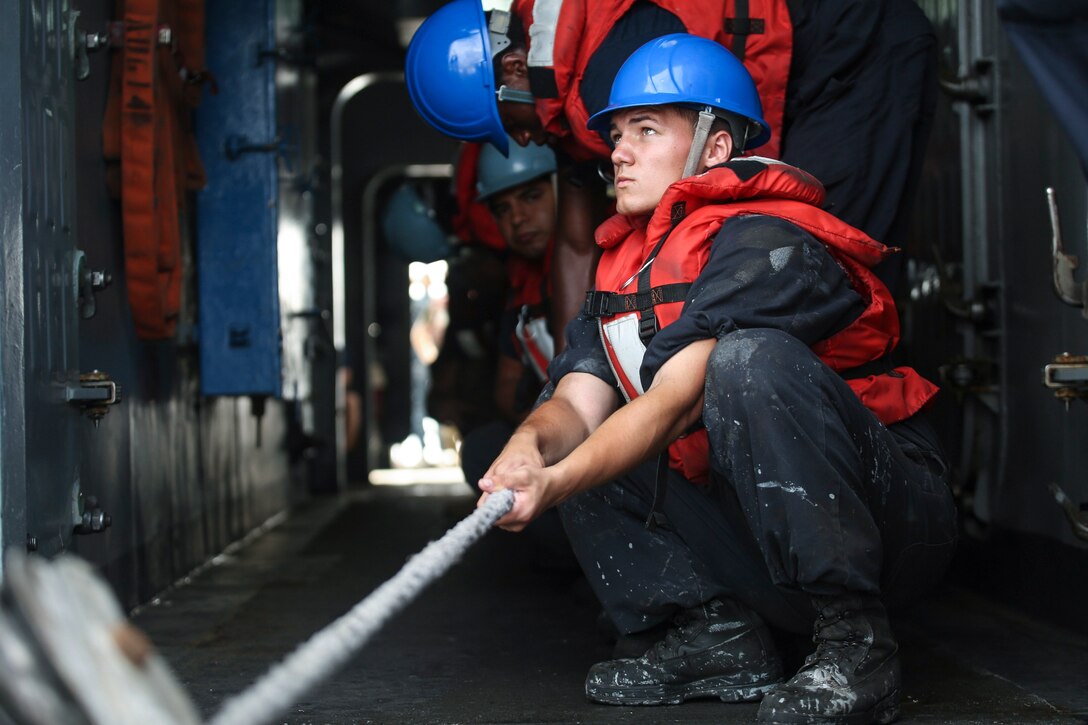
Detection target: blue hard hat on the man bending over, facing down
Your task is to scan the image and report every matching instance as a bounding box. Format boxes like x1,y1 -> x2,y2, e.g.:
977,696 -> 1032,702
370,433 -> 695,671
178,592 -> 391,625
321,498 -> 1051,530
405,0 -> 509,153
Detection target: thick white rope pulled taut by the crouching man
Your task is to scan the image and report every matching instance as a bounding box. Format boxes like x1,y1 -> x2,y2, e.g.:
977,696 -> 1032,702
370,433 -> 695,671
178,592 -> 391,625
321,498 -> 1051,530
209,491 -> 514,725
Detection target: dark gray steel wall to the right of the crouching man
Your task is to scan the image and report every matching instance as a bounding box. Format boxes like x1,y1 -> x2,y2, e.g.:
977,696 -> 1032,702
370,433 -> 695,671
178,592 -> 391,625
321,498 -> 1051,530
905,0 -> 1088,553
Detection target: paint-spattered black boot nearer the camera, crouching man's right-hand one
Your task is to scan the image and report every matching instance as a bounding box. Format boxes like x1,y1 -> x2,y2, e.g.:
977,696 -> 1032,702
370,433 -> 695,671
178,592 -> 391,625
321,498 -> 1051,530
758,594 -> 900,725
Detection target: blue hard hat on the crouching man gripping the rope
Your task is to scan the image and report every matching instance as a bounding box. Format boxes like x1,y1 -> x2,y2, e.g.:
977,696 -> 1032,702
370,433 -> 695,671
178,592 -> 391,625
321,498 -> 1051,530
586,33 -> 770,148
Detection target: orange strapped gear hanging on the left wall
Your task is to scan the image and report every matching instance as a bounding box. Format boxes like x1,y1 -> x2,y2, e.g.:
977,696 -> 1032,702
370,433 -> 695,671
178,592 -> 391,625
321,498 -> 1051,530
102,0 -> 206,340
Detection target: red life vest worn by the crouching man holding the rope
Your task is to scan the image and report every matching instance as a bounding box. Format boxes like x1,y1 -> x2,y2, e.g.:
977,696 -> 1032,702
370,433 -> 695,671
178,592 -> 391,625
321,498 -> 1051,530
586,158 -> 937,481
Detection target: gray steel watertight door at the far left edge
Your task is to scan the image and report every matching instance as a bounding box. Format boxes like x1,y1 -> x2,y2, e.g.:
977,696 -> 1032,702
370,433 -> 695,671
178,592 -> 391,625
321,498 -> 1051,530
0,0 -> 91,554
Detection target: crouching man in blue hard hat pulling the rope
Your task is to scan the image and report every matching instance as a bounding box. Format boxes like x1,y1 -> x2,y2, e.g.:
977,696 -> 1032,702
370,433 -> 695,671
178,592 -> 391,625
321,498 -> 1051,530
480,34 -> 956,723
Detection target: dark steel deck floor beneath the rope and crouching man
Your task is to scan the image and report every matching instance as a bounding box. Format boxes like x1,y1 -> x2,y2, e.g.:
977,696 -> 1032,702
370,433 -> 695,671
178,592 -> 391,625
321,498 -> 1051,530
133,484 -> 1088,725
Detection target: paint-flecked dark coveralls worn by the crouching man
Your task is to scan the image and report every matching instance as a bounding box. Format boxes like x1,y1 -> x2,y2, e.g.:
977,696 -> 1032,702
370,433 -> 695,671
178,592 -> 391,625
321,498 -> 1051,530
549,216 -> 956,632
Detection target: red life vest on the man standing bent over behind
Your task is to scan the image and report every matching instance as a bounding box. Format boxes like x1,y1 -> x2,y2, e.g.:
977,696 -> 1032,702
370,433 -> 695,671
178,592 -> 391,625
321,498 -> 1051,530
512,0 -> 793,161
